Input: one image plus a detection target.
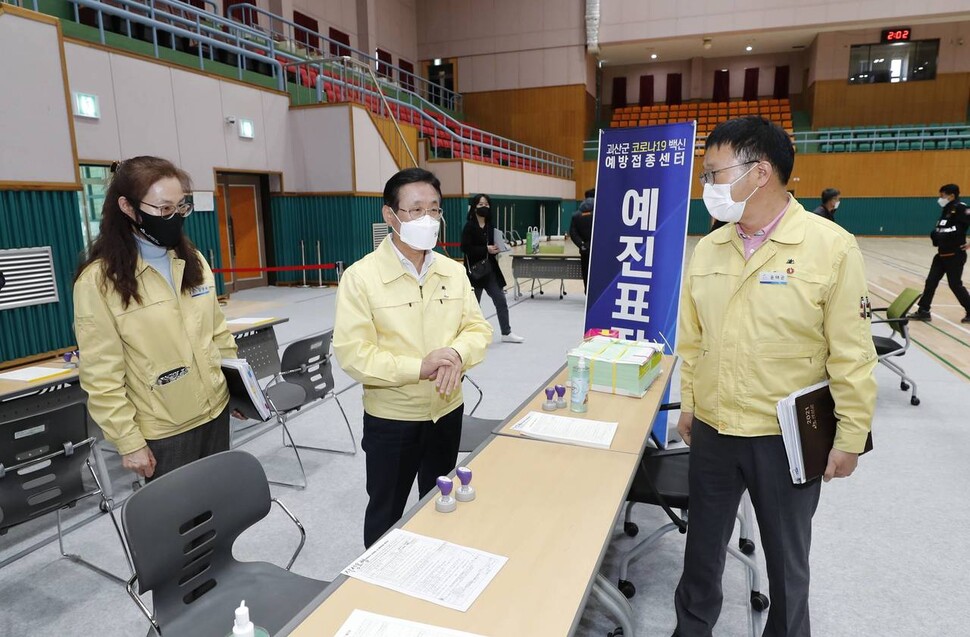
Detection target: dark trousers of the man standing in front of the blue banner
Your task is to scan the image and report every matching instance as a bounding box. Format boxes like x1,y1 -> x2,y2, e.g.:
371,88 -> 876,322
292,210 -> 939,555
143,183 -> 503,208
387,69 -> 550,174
674,418 -> 822,637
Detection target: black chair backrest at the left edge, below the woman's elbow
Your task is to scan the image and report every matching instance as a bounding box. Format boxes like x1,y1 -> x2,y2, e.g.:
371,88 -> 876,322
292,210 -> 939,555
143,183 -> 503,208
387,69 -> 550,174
0,437 -> 98,533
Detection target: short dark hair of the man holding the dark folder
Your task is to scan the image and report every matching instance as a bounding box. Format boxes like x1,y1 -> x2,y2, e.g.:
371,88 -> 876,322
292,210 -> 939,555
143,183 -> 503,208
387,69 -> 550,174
704,115 -> 795,185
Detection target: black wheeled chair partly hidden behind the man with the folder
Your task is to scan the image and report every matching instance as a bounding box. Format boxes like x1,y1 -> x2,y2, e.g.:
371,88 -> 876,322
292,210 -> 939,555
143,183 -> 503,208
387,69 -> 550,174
617,403 -> 769,634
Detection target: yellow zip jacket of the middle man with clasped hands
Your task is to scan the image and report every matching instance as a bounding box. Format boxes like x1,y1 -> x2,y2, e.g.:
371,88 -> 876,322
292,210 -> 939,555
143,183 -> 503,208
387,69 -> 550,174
333,237 -> 492,421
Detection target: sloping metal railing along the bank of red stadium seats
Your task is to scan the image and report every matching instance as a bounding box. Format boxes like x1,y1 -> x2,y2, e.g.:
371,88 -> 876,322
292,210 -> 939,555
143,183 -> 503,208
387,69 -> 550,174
296,57 -> 573,179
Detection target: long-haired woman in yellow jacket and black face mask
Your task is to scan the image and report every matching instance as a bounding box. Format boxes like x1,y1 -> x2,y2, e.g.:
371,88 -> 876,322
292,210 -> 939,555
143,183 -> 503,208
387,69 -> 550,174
74,157 -> 236,479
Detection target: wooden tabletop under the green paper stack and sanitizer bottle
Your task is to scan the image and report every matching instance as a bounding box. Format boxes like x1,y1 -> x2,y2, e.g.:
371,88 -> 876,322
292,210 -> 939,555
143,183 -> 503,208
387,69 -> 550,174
495,356 -> 677,456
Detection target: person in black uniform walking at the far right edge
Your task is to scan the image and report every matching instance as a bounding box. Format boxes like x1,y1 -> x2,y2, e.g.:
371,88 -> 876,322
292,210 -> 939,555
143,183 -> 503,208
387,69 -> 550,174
909,184 -> 970,323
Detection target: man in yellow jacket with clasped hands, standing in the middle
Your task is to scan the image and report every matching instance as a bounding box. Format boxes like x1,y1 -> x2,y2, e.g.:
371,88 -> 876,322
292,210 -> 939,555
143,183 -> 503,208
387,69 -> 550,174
333,168 -> 492,547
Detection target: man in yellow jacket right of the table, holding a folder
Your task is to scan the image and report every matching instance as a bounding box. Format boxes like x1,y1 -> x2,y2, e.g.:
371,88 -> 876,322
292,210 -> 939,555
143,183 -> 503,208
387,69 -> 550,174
674,117 -> 877,637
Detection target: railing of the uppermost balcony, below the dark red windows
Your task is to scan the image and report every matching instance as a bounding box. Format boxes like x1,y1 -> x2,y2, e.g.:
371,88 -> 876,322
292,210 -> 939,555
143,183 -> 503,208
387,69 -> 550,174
226,4 -> 463,112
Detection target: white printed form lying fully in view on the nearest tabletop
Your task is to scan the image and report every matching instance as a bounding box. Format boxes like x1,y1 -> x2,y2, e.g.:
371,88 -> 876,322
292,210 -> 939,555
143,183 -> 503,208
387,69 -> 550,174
341,529 -> 509,612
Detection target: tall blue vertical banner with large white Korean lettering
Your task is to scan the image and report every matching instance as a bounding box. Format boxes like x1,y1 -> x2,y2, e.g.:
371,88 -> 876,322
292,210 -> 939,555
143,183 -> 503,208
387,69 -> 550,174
585,122 -> 696,444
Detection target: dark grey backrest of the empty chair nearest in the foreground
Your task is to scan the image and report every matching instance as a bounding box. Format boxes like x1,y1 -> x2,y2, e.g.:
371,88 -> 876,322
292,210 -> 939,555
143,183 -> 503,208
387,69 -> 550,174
121,451 -> 270,608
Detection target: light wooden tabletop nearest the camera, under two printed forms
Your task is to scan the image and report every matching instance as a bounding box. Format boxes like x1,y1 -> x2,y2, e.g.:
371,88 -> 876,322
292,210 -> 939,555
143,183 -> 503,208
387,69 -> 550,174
281,436 -> 639,637
